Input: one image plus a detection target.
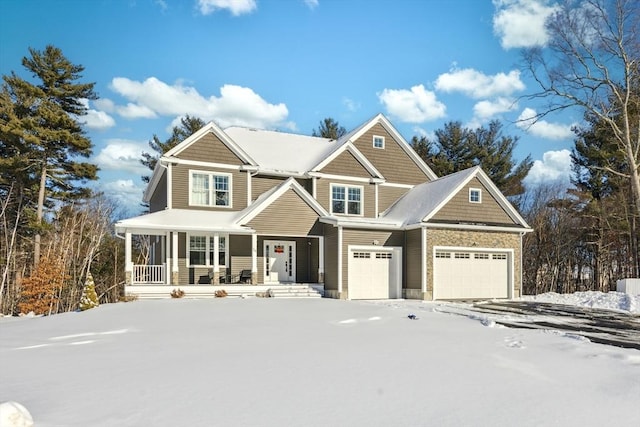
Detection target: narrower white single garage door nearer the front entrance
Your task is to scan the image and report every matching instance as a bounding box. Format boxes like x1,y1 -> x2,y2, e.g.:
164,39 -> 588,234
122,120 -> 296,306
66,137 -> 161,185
347,247 -> 402,299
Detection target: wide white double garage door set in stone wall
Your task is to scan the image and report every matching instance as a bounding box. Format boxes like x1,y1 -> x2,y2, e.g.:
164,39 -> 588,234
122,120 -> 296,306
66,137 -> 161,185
433,250 -> 511,299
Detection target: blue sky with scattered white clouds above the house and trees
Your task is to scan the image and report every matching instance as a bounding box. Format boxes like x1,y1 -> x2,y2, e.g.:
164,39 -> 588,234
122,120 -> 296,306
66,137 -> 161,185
0,0 -> 582,211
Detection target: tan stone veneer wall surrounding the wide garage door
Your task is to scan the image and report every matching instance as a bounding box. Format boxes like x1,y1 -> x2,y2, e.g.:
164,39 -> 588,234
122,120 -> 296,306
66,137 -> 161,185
424,228 -> 522,300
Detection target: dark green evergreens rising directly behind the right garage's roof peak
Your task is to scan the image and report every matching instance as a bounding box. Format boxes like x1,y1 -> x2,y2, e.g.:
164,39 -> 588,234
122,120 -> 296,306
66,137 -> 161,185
411,120 -> 533,196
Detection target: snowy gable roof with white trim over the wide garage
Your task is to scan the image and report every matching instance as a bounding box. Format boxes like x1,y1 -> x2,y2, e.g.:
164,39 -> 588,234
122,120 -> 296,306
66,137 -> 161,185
381,166 -> 530,228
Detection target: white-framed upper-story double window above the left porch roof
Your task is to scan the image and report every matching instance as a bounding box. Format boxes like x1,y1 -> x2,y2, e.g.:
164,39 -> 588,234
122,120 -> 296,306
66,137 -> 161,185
189,171 -> 232,206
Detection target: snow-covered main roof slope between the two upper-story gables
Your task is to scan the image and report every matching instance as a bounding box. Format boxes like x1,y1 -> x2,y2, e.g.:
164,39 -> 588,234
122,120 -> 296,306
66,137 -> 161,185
224,126 -> 341,174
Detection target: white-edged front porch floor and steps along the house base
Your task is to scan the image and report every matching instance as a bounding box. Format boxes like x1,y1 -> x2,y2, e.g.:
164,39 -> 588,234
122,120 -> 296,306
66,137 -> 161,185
124,283 -> 324,299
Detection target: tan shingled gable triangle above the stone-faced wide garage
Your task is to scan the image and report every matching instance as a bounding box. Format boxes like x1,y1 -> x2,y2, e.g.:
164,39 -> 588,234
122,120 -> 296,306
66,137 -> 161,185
429,177 -> 518,226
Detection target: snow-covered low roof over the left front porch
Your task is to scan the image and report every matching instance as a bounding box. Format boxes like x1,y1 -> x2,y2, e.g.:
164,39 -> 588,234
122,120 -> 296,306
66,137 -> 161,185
115,209 -> 254,234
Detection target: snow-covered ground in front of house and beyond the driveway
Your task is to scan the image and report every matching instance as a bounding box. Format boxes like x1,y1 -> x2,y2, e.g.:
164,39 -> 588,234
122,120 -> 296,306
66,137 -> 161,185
0,293 -> 640,427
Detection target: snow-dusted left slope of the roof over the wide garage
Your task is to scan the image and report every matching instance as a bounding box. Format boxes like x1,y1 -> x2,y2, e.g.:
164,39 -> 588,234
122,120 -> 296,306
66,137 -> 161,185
381,166 -> 478,226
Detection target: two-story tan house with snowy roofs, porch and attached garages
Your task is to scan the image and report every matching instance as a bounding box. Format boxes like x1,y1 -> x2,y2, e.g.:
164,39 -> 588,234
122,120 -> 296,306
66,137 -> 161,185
116,115 -> 530,300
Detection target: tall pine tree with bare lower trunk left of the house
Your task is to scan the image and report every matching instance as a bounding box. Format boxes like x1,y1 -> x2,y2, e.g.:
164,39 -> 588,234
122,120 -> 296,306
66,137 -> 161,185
0,46 -> 98,267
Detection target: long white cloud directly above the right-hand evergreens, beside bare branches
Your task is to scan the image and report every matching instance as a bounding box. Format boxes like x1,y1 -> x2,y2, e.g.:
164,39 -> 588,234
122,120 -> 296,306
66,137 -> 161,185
435,68 -> 525,98
